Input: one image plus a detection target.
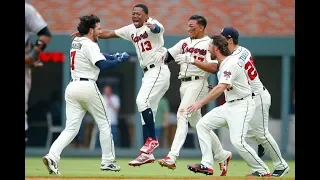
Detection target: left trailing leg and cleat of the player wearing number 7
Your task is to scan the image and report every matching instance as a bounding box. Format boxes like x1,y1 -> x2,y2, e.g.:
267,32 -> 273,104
43,82 -> 86,174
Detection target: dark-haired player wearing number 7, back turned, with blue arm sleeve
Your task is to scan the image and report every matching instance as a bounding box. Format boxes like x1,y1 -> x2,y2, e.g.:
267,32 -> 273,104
42,15 -> 129,175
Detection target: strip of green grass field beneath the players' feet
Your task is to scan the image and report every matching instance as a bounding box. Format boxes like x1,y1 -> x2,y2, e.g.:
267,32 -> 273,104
25,157 -> 295,179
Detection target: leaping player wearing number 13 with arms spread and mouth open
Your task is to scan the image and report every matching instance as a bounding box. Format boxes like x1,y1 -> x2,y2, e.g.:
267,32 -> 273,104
71,4 -> 171,166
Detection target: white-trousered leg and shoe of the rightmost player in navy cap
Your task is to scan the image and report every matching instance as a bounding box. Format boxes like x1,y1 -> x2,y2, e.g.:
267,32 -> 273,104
250,90 -> 289,176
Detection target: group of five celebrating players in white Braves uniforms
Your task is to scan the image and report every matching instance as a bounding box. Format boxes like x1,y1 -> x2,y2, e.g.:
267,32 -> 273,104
25,1 -> 289,177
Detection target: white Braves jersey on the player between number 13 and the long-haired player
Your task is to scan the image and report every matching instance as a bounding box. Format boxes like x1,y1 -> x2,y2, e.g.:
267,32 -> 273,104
168,36 -> 218,79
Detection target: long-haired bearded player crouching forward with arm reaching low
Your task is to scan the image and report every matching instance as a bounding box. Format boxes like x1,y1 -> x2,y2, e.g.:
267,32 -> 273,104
187,35 -> 270,177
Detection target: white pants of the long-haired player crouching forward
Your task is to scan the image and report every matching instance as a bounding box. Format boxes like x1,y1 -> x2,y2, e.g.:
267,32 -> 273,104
196,96 -> 270,174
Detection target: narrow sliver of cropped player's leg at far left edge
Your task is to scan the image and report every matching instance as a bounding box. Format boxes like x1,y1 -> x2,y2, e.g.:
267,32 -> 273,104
24,68 -> 31,149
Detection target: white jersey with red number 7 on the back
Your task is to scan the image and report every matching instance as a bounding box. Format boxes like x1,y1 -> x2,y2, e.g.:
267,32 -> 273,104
70,37 -> 106,81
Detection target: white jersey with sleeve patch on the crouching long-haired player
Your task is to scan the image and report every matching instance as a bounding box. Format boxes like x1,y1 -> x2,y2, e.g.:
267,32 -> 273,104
218,56 -> 252,102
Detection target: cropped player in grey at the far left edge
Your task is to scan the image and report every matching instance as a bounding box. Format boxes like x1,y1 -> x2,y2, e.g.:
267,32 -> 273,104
24,2 -> 51,148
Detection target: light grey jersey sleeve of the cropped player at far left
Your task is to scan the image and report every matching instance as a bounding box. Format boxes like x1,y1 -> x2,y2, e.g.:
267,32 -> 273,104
24,3 -> 47,43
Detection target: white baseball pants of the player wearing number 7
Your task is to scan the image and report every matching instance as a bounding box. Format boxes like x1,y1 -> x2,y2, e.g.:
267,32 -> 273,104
49,79 -> 115,164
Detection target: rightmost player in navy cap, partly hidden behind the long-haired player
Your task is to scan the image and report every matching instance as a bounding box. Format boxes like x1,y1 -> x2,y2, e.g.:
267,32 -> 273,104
221,27 -> 290,177
